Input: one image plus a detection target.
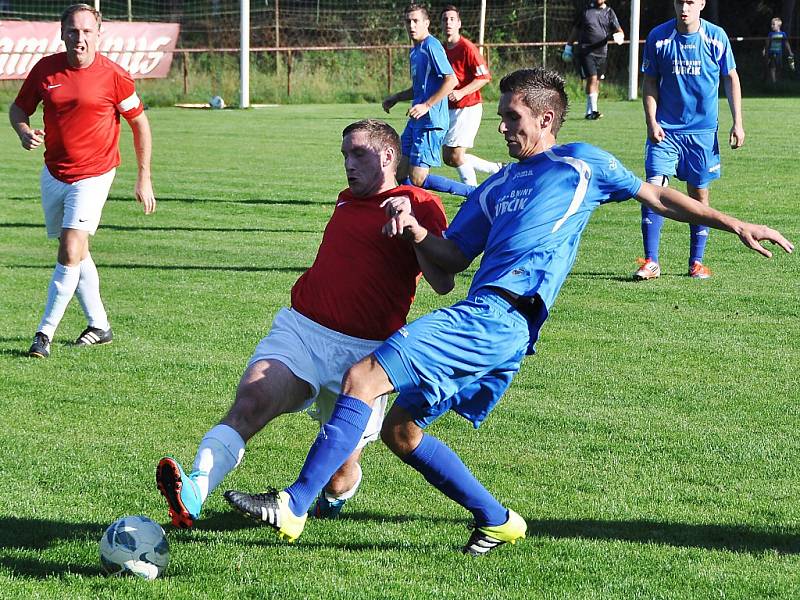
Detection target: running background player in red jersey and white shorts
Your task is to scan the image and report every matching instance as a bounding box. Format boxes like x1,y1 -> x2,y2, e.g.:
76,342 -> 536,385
441,4 -> 502,186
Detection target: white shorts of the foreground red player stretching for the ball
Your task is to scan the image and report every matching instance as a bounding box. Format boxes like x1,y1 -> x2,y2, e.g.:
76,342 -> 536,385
247,308 -> 389,448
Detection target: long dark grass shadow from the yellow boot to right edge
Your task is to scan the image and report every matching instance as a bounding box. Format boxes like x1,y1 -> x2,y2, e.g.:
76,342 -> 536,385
528,519 -> 800,554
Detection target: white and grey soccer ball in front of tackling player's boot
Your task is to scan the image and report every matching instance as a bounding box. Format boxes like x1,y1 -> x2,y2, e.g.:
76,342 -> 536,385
100,516 -> 169,580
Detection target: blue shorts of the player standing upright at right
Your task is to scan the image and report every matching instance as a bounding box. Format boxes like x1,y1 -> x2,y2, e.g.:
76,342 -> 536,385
644,130 -> 722,188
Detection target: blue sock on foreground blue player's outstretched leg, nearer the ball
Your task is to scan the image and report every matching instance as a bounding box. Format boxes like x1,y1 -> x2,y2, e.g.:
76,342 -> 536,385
286,394 -> 372,516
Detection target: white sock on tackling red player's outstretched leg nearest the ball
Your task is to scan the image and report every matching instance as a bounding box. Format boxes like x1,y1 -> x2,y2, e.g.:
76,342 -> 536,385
193,425 -> 244,502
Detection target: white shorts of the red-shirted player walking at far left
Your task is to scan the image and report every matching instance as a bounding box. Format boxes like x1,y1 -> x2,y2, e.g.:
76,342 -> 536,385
39,166 -> 117,238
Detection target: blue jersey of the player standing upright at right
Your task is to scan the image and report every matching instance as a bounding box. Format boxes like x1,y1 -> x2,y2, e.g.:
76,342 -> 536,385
642,19 -> 736,133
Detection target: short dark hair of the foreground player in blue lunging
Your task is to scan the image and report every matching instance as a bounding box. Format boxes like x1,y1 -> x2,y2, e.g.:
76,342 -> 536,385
500,67 -> 569,135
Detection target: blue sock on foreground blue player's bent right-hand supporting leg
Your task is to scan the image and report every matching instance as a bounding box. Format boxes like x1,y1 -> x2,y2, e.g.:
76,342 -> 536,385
403,434 -> 508,526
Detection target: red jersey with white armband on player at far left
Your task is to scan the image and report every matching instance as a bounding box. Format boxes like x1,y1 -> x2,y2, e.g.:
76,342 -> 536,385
14,52 -> 144,183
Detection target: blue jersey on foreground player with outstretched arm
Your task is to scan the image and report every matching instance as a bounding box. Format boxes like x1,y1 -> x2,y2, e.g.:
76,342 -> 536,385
445,143 -> 642,310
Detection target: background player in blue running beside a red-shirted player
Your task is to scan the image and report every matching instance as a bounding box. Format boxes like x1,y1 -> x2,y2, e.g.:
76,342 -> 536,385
383,4 -> 475,196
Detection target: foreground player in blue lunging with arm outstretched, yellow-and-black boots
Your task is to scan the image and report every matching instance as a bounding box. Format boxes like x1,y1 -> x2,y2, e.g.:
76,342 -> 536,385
225,68 -> 794,555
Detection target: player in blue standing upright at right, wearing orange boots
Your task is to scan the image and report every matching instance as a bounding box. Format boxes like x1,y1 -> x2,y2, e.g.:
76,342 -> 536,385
634,0 -> 744,280
